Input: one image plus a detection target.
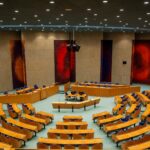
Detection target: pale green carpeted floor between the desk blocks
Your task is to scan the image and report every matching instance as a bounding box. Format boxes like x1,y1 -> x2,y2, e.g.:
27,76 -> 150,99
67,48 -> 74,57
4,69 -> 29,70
2,84 -> 150,150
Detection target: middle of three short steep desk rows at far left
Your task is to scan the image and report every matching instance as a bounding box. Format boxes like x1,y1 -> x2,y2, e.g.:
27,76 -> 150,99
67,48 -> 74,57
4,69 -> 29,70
7,104 -> 22,118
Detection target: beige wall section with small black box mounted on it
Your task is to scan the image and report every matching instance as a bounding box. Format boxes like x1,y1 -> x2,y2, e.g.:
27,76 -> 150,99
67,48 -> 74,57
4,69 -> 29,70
104,33 -> 134,84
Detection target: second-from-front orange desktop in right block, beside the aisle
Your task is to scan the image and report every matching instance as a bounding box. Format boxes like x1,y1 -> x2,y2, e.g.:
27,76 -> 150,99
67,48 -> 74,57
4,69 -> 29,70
97,115 -> 123,128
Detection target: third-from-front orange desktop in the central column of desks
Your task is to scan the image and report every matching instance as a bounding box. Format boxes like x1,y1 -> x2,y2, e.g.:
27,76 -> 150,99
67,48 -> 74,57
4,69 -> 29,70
47,129 -> 94,138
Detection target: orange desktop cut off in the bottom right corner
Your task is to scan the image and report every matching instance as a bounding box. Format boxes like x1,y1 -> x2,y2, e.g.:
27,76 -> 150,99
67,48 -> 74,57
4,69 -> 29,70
128,141 -> 150,150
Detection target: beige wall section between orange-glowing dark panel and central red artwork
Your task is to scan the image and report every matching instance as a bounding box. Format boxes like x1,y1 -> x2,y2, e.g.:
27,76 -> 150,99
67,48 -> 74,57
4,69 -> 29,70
22,32 -> 68,86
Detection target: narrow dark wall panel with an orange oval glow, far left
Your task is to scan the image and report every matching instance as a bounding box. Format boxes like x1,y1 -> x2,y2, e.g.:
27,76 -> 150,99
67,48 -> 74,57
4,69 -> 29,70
10,40 -> 26,88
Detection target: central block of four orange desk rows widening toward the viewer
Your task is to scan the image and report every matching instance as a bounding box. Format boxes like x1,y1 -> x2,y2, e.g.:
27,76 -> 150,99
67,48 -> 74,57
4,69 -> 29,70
37,116 -> 103,150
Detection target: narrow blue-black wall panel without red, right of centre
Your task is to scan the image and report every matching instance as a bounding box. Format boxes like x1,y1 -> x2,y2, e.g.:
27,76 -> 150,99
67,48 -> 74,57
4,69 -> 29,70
100,40 -> 112,82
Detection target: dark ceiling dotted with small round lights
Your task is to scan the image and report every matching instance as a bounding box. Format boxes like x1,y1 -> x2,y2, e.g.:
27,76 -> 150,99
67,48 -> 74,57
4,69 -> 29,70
0,0 -> 150,32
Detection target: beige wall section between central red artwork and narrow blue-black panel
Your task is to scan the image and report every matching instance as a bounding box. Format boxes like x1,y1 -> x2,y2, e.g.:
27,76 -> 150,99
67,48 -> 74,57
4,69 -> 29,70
75,32 -> 103,81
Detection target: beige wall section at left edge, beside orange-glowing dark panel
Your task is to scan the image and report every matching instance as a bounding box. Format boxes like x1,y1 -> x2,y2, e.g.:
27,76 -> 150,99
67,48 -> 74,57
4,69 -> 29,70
0,31 -> 19,91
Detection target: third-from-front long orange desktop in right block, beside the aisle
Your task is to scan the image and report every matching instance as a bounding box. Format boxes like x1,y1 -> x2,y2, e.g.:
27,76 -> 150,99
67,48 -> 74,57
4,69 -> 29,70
104,119 -> 139,135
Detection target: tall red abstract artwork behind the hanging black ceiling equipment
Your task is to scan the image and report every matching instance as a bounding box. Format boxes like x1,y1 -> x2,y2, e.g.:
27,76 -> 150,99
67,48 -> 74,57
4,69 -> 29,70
54,40 -> 75,83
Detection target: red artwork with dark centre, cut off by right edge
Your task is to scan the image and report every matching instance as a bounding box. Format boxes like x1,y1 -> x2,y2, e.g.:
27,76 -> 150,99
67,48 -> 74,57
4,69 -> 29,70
132,40 -> 150,84
